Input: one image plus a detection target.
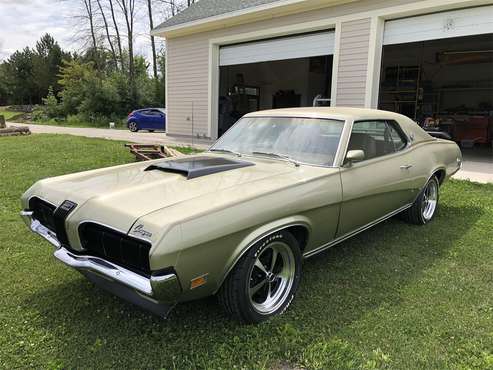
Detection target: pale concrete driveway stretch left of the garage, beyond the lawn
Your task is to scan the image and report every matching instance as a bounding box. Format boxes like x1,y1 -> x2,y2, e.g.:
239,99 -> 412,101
7,122 -> 212,149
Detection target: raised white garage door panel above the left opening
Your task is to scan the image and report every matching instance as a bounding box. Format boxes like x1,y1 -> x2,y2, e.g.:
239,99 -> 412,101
219,31 -> 335,66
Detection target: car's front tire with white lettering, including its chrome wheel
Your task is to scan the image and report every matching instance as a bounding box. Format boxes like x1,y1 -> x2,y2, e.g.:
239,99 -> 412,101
218,231 -> 301,324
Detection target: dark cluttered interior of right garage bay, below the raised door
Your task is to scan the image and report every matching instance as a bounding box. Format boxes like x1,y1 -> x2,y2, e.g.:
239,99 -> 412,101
379,34 -> 493,156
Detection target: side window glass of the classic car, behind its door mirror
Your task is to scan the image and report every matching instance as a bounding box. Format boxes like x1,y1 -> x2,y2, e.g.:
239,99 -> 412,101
348,121 -> 407,159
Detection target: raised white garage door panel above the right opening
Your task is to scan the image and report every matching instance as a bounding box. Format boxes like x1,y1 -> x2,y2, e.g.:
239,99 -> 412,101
383,6 -> 493,45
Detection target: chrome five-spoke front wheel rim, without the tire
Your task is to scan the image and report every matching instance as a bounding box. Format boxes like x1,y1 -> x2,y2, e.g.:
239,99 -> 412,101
248,241 -> 296,315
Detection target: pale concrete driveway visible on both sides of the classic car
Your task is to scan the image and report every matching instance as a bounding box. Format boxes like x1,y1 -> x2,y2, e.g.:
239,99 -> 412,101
8,123 -> 493,183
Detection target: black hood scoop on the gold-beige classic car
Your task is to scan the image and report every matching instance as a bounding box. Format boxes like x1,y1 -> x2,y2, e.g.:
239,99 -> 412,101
144,156 -> 254,180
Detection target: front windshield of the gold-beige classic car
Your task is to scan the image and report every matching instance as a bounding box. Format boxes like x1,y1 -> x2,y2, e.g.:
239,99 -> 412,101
211,117 -> 344,166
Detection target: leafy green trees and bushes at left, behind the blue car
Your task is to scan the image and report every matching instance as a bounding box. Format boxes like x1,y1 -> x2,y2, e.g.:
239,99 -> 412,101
0,34 -> 165,126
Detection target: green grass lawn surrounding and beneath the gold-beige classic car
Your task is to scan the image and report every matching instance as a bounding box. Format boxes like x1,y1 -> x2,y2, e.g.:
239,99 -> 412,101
0,135 -> 493,369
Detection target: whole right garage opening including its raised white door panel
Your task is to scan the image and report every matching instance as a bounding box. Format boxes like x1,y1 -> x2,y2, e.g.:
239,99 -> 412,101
379,6 -> 493,155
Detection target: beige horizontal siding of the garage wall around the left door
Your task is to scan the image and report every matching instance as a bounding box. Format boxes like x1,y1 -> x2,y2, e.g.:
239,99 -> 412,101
166,0 -> 416,136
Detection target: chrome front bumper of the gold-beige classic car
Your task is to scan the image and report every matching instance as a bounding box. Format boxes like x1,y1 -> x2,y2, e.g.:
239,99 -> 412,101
21,211 -> 181,308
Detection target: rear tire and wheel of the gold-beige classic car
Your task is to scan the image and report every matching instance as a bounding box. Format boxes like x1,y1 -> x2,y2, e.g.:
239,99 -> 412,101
402,176 -> 440,225
